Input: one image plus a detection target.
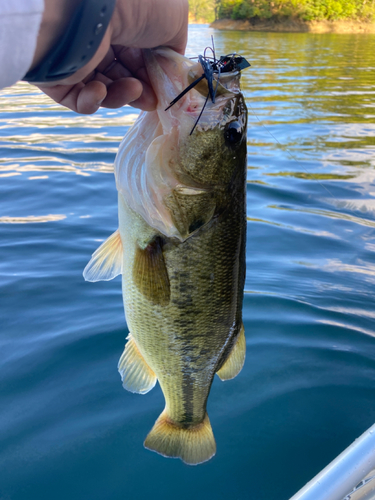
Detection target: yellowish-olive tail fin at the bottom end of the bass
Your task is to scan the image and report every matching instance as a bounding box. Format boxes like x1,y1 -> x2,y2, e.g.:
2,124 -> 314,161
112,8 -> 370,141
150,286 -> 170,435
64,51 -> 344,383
144,410 -> 216,465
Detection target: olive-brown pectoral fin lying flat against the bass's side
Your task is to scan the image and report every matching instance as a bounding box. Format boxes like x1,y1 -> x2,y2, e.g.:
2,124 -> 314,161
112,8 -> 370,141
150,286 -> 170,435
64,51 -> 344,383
133,236 -> 170,306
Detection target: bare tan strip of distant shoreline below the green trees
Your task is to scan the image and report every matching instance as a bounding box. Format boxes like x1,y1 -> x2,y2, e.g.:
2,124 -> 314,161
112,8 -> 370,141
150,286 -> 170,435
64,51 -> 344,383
210,19 -> 375,33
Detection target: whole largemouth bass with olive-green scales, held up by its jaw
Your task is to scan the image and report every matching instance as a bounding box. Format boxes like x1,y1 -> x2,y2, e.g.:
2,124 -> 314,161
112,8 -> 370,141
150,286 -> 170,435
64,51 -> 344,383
84,48 -> 247,464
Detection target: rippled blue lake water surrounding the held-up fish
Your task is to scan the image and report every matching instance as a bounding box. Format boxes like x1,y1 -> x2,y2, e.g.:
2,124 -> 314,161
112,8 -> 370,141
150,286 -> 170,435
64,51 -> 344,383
0,26 -> 375,500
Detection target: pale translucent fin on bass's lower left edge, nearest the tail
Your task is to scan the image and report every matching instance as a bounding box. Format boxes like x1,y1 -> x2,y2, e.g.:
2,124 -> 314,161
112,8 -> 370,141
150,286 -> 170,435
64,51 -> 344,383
118,334 -> 157,394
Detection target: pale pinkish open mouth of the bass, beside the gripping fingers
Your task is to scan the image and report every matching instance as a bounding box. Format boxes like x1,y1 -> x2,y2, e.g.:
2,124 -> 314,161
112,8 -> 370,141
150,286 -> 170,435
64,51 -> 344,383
143,47 -> 241,136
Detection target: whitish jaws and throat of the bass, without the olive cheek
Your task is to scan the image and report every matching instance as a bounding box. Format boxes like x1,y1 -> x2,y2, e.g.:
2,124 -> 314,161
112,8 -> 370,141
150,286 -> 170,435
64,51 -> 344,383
115,47 -> 246,242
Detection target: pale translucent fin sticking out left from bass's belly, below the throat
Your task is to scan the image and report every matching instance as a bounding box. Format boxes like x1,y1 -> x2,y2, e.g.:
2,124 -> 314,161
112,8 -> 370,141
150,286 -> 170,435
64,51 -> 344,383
83,229 -> 123,281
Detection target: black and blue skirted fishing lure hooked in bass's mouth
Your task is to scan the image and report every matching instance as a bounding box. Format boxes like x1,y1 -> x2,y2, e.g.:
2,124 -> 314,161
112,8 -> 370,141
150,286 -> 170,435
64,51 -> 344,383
165,39 -> 251,135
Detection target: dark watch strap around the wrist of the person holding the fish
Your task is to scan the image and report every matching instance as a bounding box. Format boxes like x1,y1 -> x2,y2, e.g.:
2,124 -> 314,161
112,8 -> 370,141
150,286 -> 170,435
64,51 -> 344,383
22,0 -> 116,83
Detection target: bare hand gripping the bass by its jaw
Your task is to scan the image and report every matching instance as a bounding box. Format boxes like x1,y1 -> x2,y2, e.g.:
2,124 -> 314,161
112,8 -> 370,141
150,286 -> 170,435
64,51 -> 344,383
33,0 -> 188,114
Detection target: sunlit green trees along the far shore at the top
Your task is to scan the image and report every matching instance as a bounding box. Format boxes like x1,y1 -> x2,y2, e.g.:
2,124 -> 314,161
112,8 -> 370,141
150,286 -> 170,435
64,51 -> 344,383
189,0 -> 375,22
